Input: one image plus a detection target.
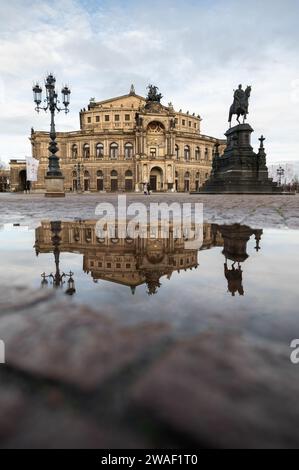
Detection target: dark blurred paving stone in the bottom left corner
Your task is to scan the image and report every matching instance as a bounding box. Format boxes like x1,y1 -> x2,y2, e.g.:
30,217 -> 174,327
0,374 -> 148,449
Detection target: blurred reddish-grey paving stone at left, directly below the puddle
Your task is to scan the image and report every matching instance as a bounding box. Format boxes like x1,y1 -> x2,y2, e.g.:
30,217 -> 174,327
0,292 -> 168,391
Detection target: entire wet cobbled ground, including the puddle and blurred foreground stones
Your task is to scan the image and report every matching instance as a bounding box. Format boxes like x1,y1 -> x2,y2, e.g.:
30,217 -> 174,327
0,195 -> 299,448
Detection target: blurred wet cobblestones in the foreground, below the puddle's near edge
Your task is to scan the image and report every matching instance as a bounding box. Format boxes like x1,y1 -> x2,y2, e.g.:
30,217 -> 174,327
0,286 -> 299,449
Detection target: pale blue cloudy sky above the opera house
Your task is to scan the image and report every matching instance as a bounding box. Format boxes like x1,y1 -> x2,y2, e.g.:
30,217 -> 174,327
0,0 -> 299,162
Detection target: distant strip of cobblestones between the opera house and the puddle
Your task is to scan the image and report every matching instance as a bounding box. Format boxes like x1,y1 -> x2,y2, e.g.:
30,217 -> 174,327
0,193 -> 299,229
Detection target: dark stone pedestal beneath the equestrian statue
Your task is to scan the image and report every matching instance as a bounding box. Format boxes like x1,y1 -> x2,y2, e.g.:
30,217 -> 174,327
201,124 -> 279,194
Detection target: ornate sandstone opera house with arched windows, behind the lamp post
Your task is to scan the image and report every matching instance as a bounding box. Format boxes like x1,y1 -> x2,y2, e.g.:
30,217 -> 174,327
12,86 -> 225,192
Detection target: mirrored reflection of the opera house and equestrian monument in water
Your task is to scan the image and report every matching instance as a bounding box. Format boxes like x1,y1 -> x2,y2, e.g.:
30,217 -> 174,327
35,220 -> 262,295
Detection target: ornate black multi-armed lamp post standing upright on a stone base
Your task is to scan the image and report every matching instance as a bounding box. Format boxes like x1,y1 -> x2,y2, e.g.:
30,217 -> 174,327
32,74 -> 71,197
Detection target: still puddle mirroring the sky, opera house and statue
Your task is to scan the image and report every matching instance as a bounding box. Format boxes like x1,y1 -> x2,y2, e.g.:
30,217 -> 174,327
0,220 -> 299,339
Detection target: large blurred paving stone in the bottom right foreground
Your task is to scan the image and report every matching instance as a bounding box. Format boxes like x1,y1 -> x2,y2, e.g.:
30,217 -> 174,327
132,333 -> 299,448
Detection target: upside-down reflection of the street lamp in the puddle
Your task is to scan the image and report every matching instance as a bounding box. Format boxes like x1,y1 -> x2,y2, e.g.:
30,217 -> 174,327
41,221 -> 76,295
